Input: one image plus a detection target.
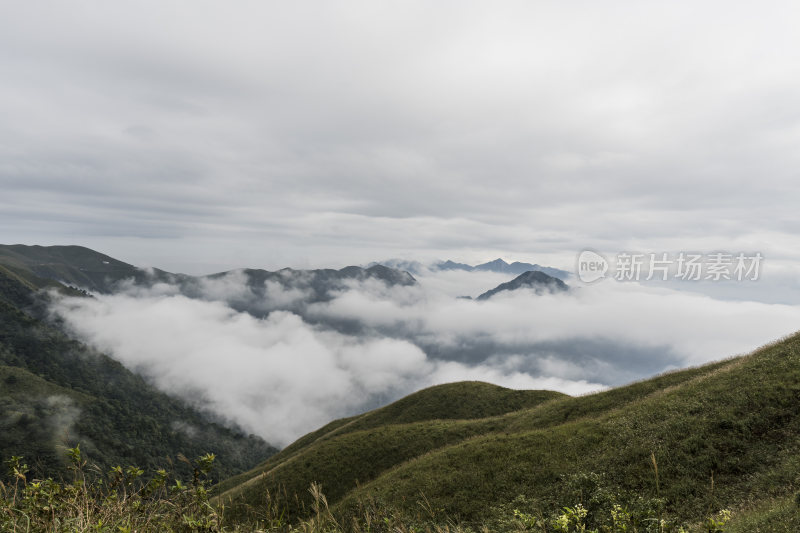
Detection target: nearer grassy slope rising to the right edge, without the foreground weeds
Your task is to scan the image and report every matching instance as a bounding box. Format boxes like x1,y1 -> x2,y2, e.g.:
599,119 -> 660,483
341,336 -> 800,521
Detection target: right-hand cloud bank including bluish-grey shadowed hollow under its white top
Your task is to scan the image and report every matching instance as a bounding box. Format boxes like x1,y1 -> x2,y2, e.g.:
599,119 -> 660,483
309,272 -> 800,372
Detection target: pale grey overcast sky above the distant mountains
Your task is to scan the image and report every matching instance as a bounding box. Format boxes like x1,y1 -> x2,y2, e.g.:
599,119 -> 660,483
0,0 -> 800,280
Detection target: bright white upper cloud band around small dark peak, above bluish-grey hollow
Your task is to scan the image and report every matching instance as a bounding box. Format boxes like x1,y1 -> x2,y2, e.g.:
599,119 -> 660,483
311,270 -> 800,364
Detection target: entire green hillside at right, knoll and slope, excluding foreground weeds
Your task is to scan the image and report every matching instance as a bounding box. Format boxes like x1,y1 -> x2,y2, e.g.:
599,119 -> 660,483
219,335 -> 800,531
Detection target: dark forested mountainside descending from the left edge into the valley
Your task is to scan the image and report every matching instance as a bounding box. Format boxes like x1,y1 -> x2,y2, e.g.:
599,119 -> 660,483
0,264 -> 274,477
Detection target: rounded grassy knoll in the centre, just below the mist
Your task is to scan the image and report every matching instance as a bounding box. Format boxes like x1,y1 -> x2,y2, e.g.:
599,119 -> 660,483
212,382 -> 566,513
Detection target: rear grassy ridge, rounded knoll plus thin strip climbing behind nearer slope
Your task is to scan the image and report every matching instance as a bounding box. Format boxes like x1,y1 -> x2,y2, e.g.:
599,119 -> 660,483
214,362 -> 731,515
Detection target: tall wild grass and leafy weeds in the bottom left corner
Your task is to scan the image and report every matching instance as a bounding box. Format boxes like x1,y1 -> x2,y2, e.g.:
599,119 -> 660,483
0,447 -> 221,533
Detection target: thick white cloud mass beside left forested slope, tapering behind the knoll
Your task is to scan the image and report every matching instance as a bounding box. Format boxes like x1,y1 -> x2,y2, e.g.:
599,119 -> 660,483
54,280 -> 600,445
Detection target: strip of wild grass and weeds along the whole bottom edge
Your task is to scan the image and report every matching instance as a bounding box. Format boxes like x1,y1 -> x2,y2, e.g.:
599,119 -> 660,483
0,447 -> 756,533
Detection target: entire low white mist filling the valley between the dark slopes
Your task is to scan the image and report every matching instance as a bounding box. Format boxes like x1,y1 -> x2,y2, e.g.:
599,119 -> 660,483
48,271 -> 800,445
